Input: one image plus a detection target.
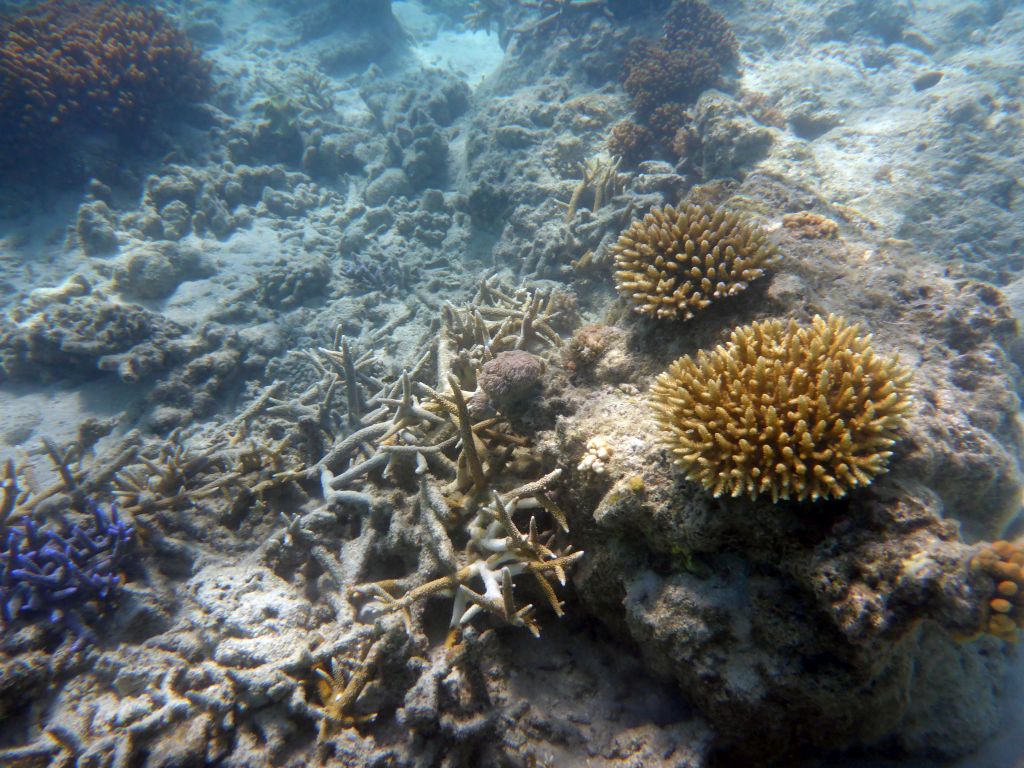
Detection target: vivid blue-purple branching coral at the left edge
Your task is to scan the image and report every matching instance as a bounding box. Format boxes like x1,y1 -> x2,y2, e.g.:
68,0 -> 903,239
0,503 -> 134,650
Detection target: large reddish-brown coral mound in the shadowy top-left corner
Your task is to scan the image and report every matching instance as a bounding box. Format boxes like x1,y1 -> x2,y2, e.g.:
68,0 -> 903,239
0,0 -> 209,174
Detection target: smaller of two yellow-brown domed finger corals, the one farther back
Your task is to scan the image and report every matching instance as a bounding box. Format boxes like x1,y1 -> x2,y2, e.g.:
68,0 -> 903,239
611,204 -> 775,319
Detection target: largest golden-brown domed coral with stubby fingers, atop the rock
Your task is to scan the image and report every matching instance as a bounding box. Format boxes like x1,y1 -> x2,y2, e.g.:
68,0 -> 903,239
652,315 -> 910,501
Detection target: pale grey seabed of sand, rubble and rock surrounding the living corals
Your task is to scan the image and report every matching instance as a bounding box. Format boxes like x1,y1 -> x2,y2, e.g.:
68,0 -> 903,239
0,0 -> 1024,768
